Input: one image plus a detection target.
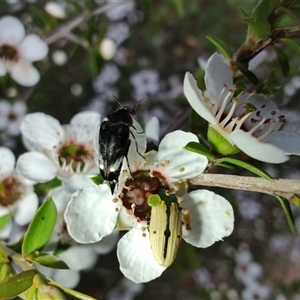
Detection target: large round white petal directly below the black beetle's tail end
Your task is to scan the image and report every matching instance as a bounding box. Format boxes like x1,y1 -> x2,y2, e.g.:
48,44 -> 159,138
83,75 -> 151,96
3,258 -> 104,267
65,184 -> 120,243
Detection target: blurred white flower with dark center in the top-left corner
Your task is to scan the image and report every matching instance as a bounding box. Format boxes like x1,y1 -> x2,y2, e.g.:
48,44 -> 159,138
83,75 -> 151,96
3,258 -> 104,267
0,16 -> 48,86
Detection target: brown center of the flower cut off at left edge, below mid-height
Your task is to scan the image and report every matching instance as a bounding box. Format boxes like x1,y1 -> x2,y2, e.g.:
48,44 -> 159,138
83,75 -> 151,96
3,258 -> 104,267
0,177 -> 25,207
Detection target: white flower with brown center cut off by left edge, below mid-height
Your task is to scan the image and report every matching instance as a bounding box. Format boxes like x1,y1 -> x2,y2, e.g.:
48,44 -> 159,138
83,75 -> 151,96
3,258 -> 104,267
0,147 -> 38,239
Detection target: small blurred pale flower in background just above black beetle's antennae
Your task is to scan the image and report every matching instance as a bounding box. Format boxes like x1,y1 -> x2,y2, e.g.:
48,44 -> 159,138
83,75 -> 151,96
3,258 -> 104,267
130,69 -> 160,99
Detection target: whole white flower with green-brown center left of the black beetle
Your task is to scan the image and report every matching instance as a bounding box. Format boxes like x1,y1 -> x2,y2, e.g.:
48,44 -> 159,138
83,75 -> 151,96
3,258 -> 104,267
17,112 -> 100,191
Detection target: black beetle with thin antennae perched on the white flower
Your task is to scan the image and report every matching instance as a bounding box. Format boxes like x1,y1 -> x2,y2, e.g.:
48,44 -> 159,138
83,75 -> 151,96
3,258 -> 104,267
98,100 -> 142,192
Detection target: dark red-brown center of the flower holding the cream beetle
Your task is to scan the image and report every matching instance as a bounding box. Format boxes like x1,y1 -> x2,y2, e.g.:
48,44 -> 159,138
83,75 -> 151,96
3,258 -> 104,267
121,170 -> 169,221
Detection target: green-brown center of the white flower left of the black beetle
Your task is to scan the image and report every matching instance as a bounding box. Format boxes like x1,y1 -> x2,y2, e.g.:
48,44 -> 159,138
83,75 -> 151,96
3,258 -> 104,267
58,142 -> 94,172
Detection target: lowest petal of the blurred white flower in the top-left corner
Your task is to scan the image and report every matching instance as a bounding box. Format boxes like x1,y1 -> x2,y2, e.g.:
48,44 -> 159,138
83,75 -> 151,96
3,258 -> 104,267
9,60 -> 40,87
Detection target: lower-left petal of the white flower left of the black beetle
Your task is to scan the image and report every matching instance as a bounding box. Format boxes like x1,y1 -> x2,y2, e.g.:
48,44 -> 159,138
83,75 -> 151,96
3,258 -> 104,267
17,152 -> 58,182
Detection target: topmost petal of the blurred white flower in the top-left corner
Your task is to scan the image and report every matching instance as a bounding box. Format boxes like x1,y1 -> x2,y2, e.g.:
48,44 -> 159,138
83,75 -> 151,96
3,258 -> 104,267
0,16 -> 25,45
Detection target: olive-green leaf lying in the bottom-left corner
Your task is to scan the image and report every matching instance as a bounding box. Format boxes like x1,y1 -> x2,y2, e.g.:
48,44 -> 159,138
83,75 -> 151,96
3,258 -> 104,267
0,270 -> 37,299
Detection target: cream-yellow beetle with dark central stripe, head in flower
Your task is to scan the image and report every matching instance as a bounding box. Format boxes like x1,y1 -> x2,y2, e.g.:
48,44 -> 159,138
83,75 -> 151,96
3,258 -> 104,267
149,191 -> 182,267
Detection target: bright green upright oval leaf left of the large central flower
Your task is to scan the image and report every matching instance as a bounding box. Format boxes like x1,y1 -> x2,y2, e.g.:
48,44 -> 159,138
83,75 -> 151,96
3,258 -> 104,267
22,199 -> 57,255
